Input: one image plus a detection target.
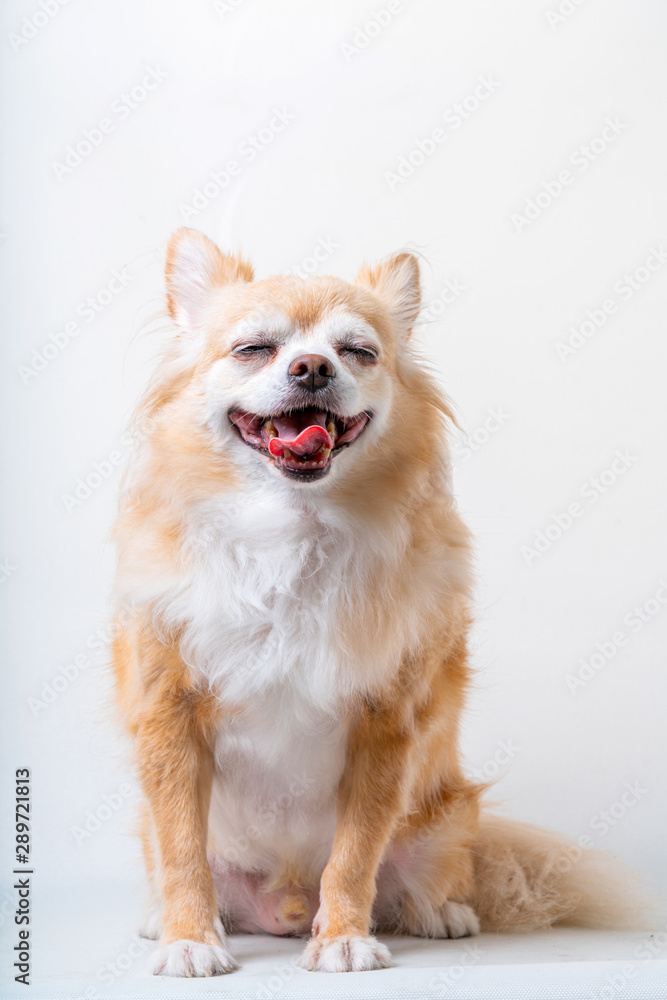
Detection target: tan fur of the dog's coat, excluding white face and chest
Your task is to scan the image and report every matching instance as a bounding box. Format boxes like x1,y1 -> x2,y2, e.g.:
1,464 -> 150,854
114,231 -> 656,974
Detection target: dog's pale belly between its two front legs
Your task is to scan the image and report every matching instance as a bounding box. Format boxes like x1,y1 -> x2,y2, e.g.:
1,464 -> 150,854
209,691 -> 347,934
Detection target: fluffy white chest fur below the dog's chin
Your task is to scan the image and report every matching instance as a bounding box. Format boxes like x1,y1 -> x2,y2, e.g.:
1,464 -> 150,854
175,503 -> 392,714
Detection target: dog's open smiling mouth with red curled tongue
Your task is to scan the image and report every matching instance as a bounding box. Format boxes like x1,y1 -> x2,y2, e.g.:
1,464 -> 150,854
229,407 -> 371,482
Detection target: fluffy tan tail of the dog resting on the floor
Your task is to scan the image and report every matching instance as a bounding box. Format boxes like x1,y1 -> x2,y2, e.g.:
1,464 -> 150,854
474,815 -> 657,931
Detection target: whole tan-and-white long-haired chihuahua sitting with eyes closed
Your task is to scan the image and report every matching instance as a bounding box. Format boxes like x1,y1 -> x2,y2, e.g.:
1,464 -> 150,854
114,229 -> 634,976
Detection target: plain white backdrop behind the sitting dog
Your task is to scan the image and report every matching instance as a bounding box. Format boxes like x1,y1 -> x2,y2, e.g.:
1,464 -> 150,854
0,0 -> 667,916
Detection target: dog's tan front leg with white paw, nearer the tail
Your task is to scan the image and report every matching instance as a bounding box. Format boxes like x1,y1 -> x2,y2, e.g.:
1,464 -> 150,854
301,707 -> 411,972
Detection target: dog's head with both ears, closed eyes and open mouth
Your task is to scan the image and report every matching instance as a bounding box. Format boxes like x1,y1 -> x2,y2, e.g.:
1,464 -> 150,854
155,229 -> 448,490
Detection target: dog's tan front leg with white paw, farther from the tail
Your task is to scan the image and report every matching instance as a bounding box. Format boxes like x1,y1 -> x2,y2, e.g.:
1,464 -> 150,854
136,684 -> 236,976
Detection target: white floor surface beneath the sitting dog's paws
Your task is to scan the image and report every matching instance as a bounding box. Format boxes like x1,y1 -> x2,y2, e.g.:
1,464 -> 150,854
0,883 -> 667,1000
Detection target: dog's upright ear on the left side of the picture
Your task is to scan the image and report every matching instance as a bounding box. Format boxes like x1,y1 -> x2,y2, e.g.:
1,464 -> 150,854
165,226 -> 253,330
